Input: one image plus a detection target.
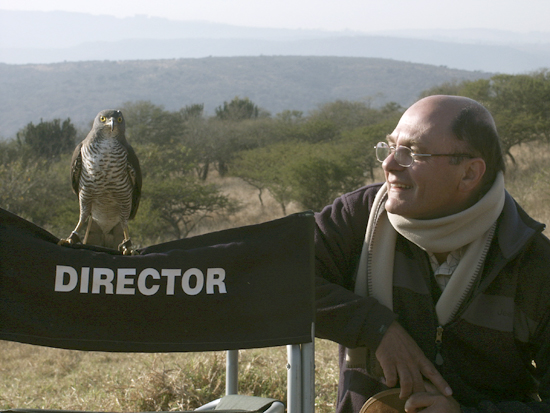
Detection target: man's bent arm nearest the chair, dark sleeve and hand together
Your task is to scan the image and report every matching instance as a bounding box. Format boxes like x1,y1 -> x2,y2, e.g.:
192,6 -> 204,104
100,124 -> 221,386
315,186 -> 449,396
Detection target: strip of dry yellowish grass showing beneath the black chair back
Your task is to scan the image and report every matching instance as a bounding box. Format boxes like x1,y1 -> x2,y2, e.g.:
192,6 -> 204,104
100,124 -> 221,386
0,340 -> 338,413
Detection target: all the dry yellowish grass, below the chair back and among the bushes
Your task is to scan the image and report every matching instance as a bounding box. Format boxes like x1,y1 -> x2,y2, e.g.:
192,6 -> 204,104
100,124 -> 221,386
0,144 -> 550,413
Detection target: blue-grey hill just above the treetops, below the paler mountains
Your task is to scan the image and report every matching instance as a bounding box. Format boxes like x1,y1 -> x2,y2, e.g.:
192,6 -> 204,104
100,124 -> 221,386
0,56 -> 490,139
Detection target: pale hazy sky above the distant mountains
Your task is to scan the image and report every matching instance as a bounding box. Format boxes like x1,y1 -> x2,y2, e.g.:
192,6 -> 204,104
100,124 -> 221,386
0,0 -> 550,32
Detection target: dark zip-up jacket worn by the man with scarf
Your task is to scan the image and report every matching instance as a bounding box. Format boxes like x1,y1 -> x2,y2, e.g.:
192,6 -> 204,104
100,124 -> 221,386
315,184 -> 550,413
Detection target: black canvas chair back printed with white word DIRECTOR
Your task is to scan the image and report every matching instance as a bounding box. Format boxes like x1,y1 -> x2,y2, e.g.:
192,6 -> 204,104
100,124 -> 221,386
0,209 -> 314,413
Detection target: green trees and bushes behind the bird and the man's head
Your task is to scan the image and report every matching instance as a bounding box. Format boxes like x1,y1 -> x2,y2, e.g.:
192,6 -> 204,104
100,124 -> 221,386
0,71 -> 550,245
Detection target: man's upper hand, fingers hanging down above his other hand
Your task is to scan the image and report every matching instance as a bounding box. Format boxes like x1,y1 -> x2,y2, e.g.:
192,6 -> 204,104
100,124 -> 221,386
376,321 -> 452,399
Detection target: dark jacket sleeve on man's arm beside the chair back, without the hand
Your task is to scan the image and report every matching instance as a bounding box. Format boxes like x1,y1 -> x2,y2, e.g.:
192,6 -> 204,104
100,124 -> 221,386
315,186 -> 396,350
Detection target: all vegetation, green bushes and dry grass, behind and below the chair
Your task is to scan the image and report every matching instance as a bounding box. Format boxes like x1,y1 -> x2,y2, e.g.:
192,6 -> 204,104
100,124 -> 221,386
0,71 -> 550,413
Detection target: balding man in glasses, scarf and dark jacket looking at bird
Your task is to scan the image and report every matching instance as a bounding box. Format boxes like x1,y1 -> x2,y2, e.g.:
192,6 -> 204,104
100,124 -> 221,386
315,96 -> 550,413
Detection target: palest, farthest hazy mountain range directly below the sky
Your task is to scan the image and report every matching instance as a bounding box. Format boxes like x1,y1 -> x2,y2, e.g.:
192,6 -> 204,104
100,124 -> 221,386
0,10 -> 550,73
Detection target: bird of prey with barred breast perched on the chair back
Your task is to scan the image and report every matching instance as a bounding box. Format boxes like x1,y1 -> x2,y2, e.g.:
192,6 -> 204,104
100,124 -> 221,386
59,109 -> 142,255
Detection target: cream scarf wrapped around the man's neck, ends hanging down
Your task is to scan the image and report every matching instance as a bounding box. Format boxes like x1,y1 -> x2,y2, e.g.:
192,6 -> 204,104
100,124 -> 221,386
348,173 -> 505,365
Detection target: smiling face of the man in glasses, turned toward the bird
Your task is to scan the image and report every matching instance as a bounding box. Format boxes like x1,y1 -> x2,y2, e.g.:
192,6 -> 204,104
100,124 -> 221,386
382,101 -> 470,219
